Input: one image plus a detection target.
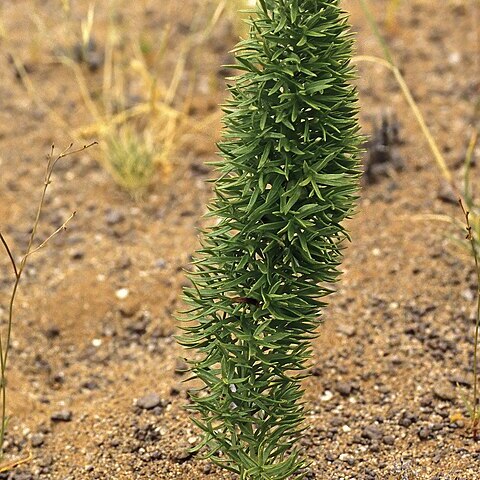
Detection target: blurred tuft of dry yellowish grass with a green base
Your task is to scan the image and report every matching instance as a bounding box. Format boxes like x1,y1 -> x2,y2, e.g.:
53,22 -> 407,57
65,2 -> 180,196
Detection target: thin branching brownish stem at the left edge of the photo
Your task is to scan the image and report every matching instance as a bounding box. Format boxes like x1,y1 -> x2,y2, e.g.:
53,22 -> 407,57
0,142 -> 96,464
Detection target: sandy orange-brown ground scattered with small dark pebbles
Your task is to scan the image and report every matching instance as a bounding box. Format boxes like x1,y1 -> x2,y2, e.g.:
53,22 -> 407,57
0,0 -> 480,480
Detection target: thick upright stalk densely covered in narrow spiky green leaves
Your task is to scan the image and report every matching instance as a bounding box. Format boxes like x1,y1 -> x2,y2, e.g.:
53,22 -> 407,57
179,0 -> 359,480
